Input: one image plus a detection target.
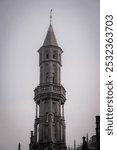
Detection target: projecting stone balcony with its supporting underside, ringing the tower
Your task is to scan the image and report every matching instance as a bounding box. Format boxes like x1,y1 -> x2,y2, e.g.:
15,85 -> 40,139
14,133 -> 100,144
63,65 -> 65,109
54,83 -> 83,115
34,84 -> 66,101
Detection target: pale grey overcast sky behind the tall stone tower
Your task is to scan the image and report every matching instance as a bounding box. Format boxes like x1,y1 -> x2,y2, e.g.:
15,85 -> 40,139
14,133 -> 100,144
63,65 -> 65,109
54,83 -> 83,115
0,0 -> 100,150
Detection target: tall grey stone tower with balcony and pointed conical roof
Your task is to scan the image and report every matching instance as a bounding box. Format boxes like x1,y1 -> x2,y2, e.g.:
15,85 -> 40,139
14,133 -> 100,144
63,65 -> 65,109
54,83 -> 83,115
29,22 -> 66,150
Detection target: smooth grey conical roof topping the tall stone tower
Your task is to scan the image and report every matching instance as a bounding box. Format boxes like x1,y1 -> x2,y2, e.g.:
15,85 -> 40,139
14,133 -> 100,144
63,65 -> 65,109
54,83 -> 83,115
43,23 -> 58,46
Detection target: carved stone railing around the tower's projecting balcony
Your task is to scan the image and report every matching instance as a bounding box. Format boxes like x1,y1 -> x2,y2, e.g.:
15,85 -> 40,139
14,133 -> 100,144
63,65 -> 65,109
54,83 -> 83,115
34,84 -> 66,97
